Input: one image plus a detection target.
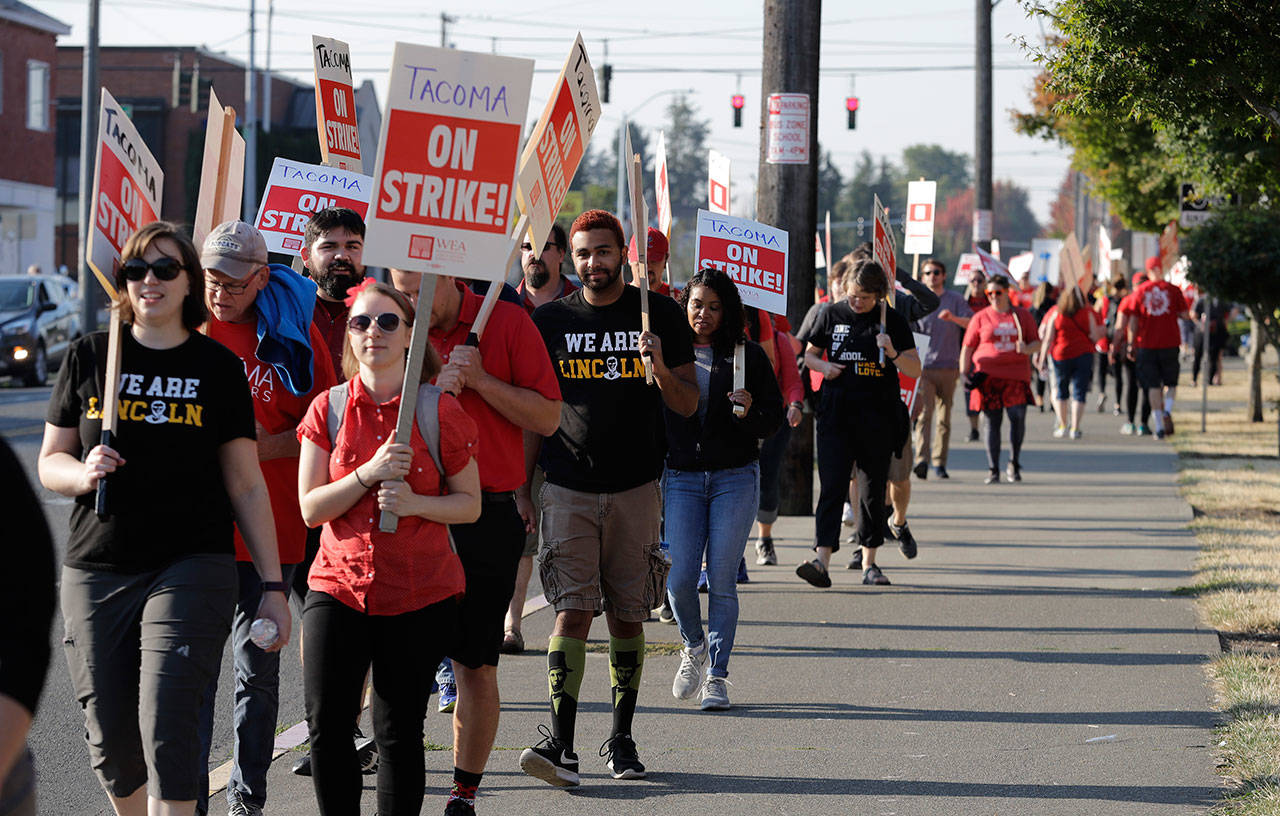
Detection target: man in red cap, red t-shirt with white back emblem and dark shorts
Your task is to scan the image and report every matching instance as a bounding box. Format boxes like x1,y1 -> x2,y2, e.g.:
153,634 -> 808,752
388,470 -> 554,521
1121,256 -> 1189,439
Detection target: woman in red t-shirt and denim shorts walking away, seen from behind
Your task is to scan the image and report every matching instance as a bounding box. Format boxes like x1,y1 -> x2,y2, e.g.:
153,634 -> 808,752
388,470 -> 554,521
1036,286 -> 1103,439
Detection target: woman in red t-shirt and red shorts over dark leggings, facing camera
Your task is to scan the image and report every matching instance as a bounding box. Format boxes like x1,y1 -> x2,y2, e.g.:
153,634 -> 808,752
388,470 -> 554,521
960,275 -> 1039,485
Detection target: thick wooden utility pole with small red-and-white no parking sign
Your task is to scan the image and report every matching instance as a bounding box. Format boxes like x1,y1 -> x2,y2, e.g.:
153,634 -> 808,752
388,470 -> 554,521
755,0 -> 824,515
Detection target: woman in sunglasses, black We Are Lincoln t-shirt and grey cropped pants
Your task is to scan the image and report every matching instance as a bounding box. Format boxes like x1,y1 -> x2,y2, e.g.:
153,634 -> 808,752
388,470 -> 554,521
40,221 -> 291,816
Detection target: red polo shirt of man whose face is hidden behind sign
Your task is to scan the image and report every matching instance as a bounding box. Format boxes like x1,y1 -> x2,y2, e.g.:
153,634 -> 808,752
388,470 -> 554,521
428,281 -> 560,492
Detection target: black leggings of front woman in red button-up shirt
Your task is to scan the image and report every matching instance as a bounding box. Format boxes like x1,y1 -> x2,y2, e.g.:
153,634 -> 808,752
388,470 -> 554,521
302,590 -> 457,816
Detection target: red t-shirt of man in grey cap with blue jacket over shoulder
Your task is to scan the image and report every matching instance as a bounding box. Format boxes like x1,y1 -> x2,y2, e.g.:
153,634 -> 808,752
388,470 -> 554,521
209,318 -> 338,564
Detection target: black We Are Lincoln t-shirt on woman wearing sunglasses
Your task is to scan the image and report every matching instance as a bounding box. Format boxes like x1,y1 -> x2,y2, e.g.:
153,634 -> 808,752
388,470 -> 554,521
47,326 -> 256,573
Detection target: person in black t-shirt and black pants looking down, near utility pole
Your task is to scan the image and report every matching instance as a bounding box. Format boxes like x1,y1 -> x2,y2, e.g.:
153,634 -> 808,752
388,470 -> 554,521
796,260 -> 920,587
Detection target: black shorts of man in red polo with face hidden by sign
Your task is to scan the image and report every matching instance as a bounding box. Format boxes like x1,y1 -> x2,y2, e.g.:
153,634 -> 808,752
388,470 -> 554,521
449,494 -> 525,669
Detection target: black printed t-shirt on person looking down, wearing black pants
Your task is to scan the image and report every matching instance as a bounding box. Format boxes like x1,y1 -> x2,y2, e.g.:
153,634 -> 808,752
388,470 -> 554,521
808,301 -> 915,398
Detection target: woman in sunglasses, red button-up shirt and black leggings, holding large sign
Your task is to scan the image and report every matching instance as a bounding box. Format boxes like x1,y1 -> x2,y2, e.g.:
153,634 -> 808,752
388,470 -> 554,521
298,279 -> 480,816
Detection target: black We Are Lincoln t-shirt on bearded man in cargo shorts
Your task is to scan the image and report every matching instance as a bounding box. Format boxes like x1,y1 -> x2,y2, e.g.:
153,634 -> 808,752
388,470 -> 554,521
534,286 -> 694,492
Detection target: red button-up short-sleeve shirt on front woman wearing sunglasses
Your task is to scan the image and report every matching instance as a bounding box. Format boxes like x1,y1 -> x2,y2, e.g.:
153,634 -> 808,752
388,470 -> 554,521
298,373 -> 481,615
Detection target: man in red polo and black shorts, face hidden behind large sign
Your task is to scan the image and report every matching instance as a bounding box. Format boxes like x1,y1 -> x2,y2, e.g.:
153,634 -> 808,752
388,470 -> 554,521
392,270 -> 561,813
